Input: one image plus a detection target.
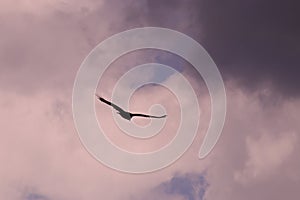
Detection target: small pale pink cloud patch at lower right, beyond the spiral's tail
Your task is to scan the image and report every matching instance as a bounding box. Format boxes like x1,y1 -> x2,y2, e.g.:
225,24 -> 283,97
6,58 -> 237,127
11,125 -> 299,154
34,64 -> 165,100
234,133 -> 297,183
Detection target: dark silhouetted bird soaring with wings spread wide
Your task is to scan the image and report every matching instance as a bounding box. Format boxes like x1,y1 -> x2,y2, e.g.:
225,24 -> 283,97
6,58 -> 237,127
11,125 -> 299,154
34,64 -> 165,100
96,94 -> 167,121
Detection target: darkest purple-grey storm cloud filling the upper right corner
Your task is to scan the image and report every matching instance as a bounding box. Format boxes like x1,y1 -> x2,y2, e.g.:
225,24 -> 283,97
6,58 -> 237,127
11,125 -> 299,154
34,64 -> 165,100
199,0 -> 300,95
